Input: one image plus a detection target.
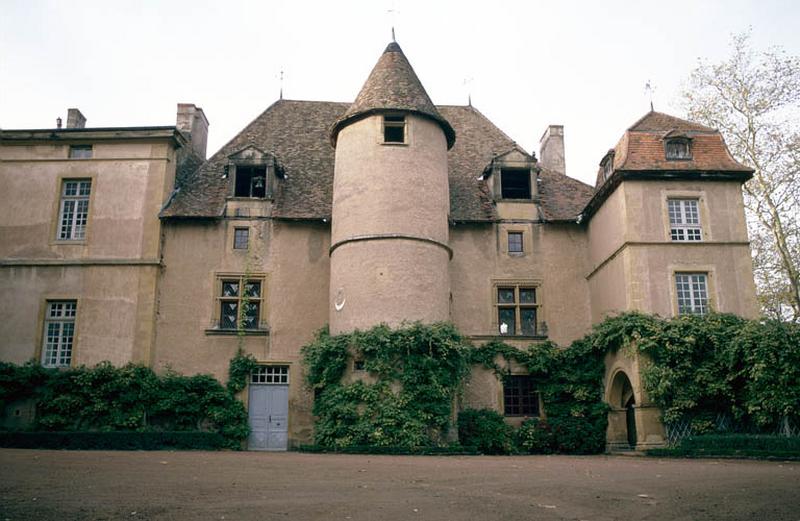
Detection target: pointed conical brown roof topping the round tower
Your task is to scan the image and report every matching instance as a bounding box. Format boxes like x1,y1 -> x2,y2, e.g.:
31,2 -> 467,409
331,42 -> 456,149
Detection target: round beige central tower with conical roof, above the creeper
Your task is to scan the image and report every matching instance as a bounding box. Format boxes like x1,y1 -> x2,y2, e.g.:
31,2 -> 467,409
330,42 -> 455,334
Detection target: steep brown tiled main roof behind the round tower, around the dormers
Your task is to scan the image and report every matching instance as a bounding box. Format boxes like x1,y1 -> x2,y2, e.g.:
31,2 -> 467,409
161,100 -> 592,221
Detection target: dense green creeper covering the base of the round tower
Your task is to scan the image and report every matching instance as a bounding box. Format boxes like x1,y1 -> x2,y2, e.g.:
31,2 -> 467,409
302,323 -> 469,449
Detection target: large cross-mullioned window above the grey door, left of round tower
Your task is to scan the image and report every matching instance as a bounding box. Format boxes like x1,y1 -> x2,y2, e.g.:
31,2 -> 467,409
218,277 -> 263,329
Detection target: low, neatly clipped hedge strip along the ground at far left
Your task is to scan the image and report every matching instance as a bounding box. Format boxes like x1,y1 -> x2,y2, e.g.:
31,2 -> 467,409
0,431 -> 229,450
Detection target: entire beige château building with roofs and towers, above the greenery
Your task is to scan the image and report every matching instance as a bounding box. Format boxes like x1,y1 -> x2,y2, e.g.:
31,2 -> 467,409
0,42 -> 757,450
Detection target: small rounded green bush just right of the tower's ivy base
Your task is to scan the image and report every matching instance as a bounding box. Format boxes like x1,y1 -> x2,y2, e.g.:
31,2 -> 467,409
458,409 -> 515,454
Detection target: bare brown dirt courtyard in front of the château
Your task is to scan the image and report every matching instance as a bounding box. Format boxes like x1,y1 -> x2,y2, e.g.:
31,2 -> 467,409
0,449 -> 800,521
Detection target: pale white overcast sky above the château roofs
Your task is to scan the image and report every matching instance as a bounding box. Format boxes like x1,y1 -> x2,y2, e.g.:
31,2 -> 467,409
0,0 -> 800,184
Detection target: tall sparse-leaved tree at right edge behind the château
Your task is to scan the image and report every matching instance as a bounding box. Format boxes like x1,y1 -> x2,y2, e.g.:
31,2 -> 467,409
683,33 -> 800,322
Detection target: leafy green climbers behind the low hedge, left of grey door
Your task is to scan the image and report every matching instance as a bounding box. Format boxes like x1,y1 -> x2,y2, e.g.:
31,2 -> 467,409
0,362 -> 249,448
